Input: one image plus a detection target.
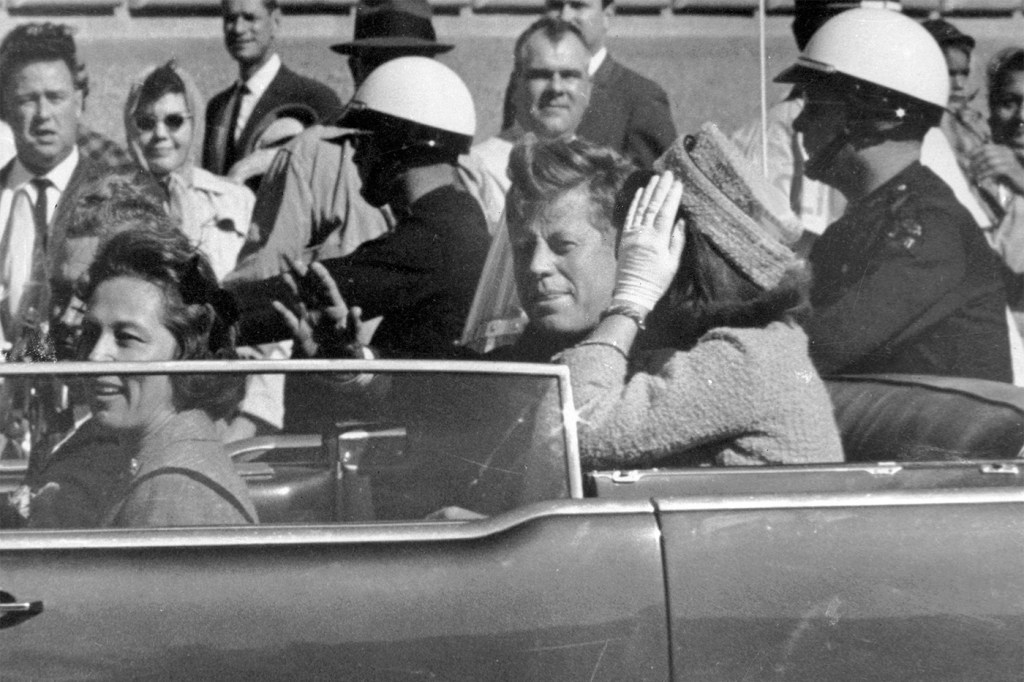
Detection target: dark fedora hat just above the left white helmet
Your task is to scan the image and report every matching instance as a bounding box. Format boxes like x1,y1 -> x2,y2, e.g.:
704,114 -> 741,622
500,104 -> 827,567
331,0 -> 453,55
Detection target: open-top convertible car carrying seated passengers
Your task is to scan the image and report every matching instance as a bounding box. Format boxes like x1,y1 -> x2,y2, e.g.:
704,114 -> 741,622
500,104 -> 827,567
0,360 -> 1024,682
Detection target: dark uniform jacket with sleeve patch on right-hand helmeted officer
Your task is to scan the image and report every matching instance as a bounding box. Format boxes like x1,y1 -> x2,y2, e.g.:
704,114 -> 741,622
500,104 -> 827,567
807,163 -> 1013,381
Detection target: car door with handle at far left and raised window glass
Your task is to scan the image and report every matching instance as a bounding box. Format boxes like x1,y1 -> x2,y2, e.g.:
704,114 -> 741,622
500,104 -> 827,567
0,361 -> 669,680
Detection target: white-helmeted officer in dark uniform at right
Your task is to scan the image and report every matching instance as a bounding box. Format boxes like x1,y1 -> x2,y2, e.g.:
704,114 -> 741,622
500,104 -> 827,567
775,8 -> 1013,381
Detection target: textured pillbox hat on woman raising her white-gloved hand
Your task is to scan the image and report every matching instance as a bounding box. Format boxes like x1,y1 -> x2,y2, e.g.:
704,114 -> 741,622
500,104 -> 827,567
654,123 -> 803,290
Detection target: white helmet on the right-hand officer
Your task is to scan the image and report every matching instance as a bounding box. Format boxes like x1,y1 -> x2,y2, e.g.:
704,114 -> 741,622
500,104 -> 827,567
775,8 -> 949,125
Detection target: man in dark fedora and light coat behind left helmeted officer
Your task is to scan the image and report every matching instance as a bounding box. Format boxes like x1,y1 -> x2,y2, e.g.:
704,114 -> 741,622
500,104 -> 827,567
227,0 -> 453,283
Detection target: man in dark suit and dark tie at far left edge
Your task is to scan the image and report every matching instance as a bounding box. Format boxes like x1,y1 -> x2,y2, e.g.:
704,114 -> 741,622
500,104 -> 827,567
0,24 -> 109,348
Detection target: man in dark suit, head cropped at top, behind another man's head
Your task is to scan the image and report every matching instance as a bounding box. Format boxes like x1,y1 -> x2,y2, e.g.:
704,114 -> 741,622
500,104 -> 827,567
502,0 -> 676,168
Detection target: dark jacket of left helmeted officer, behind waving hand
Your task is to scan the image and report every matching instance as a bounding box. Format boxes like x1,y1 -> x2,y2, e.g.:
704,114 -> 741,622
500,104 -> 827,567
232,185 -> 490,357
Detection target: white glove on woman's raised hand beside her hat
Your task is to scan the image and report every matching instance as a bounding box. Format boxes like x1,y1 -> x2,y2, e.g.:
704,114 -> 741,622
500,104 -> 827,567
611,171 -> 686,312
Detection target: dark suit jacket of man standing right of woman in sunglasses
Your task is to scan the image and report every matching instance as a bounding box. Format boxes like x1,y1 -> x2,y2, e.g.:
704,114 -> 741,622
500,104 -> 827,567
203,65 -> 341,175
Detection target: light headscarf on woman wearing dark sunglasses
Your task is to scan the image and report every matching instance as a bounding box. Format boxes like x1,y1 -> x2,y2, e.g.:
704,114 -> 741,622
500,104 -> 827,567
124,59 -> 206,238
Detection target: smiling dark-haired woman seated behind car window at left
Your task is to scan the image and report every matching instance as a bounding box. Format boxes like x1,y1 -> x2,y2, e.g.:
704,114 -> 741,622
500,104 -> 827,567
21,229 -> 257,527
